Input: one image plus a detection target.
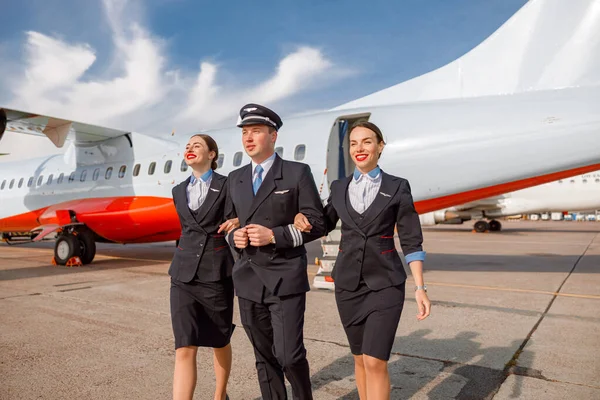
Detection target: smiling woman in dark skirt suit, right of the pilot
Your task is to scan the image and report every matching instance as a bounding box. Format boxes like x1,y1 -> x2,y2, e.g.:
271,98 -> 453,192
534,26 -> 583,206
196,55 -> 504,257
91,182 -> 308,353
295,122 -> 431,400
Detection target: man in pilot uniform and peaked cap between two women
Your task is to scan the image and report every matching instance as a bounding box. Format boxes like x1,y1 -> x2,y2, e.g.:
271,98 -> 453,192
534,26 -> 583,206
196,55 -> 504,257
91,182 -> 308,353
227,104 -> 326,400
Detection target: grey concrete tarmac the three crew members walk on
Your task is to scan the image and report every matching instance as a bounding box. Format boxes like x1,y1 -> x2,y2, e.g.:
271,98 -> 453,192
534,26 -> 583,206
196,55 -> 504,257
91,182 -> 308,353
0,221 -> 600,400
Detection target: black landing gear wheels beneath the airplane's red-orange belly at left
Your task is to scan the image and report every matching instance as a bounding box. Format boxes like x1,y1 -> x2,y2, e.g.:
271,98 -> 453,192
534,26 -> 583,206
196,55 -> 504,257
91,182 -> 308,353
54,227 -> 96,265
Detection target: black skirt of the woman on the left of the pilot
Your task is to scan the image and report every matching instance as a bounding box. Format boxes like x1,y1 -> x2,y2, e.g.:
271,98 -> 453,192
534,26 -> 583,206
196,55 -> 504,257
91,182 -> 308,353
171,277 -> 235,349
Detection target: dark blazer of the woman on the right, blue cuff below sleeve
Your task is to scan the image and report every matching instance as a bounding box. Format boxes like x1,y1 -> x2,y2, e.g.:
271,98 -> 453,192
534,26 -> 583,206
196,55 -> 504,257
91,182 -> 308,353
325,171 -> 423,291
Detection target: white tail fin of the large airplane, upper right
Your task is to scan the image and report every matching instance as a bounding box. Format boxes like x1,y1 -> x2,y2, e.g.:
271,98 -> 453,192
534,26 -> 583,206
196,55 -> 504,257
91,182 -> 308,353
335,0 -> 600,109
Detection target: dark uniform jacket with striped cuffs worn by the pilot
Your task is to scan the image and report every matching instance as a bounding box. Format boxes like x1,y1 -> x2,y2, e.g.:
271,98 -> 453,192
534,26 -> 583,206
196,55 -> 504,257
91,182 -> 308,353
228,155 -> 325,302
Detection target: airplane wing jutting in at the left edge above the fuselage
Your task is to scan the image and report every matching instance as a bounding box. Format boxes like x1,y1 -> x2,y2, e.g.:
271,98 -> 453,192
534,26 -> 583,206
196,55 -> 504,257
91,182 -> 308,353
0,108 -> 131,147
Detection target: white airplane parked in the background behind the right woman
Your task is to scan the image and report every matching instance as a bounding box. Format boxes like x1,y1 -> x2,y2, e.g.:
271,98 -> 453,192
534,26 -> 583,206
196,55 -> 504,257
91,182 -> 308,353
419,171 -> 600,233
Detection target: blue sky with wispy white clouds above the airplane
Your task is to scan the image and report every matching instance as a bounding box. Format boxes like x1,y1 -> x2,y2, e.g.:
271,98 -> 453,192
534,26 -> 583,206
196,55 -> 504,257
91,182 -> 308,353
0,0 -> 526,159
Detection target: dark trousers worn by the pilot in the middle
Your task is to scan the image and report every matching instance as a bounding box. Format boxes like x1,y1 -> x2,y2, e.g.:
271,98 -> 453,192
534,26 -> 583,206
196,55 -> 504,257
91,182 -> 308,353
239,290 -> 313,400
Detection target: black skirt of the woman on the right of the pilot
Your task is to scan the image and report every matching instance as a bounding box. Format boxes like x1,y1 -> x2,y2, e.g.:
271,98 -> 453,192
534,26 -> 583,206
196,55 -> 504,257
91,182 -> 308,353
335,282 -> 405,361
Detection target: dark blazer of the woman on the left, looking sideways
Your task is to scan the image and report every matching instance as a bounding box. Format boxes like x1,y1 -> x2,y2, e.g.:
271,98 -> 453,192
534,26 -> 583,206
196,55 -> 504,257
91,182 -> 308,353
169,171 -> 235,282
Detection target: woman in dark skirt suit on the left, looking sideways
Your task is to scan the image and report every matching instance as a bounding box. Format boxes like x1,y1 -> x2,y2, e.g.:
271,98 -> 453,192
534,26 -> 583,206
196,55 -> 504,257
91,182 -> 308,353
169,135 -> 238,400
